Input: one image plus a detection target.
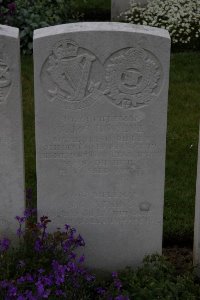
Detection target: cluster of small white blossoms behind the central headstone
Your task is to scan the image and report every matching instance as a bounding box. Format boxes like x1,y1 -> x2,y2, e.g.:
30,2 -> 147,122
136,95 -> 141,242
120,0 -> 200,45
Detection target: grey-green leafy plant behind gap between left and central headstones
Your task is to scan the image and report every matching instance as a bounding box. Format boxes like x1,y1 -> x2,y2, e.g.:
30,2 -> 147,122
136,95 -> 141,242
14,0 -> 81,54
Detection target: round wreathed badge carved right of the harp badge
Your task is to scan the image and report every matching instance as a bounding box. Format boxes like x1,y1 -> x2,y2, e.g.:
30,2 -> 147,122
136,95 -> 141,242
105,46 -> 162,109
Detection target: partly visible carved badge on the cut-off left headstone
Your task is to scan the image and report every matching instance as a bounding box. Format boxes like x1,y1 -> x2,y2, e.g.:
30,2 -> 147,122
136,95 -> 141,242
0,49 -> 11,104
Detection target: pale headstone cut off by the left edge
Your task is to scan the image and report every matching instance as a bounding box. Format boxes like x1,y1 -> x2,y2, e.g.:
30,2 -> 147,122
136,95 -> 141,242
0,25 -> 24,238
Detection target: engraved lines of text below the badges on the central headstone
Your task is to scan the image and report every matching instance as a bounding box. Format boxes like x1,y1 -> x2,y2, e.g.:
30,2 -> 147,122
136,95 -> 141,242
38,106 -> 159,224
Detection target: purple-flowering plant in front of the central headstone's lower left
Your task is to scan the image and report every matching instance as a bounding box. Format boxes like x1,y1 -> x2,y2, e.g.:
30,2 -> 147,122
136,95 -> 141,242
0,209 -> 128,300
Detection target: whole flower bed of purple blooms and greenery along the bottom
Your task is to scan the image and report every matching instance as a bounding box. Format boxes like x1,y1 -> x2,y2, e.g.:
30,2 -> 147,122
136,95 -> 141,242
0,209 -> 200,300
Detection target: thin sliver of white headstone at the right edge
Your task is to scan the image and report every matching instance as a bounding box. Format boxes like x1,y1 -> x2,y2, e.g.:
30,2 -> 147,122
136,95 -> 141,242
193,123 -> 200,275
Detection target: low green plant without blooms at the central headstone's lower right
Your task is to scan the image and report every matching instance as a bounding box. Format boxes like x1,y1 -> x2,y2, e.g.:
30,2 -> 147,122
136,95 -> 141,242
120,255 -> 200,300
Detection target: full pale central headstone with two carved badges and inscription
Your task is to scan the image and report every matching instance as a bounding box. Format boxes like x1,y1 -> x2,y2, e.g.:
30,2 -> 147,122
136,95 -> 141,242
34,23 -> 170,270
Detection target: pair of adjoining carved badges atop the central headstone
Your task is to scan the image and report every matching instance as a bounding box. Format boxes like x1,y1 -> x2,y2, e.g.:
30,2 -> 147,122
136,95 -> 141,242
41,40 -> 163,109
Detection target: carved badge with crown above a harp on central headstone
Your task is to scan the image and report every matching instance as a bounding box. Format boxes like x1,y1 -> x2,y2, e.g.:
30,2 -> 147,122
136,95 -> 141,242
41,40 -> 102,109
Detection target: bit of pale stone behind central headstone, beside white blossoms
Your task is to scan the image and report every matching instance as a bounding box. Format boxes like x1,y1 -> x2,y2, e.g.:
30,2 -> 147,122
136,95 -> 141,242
111,0 -> 147,20
